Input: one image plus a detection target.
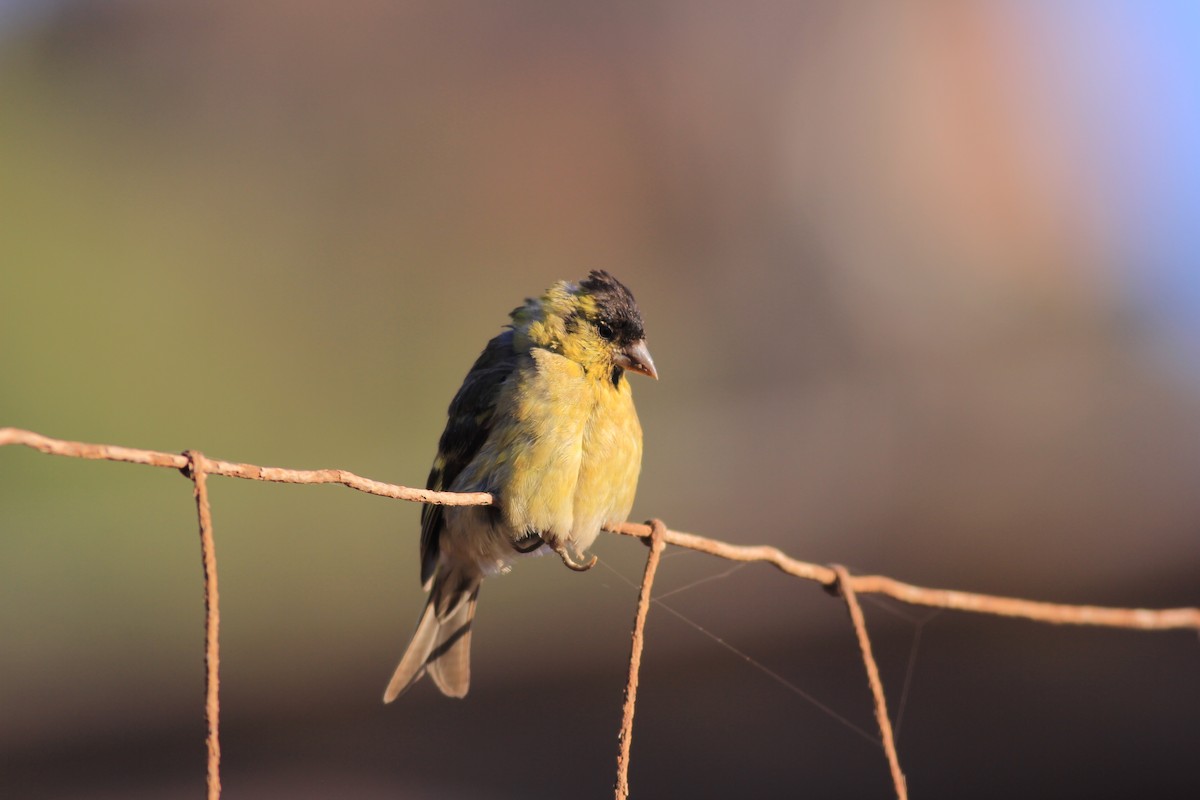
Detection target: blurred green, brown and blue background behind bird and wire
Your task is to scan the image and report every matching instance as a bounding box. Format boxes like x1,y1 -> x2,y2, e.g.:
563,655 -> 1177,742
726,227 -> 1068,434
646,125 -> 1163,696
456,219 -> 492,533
0,0 -> 1200,799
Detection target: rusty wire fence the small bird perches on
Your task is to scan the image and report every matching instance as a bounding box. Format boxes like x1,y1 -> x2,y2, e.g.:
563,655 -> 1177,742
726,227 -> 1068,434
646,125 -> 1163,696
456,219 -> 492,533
0,428 -> 1200,800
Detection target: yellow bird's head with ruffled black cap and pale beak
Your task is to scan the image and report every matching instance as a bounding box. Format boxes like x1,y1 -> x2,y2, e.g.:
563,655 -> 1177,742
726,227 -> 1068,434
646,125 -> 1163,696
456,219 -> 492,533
512,270 -> 659,383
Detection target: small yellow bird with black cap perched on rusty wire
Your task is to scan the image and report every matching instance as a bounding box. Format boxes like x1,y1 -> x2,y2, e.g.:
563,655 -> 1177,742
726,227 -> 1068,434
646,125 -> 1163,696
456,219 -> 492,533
383,270 -> 659,703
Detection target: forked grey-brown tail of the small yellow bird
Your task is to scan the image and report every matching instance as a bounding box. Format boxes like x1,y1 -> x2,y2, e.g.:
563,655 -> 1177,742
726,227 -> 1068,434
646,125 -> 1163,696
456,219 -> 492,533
383,570 -> 482,703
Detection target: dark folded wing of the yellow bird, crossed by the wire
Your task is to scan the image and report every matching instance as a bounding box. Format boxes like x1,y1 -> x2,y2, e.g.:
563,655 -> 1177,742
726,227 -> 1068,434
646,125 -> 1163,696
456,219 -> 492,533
421,330 -> 517,584
